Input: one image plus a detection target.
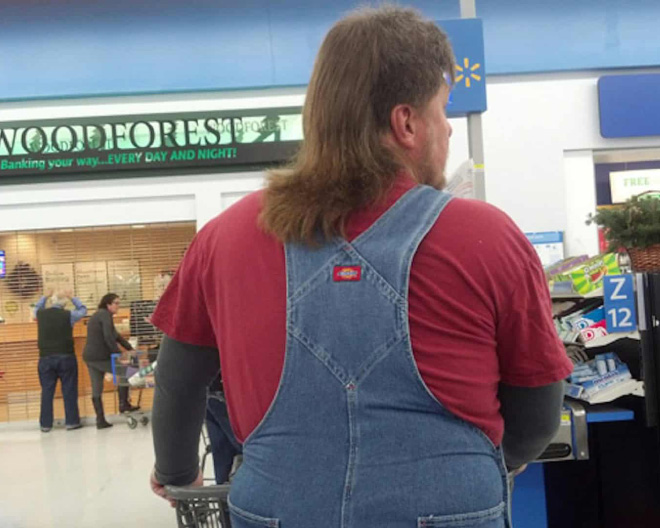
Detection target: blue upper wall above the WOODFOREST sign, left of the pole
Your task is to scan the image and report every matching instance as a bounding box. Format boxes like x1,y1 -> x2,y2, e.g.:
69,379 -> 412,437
0,0 -> 459,100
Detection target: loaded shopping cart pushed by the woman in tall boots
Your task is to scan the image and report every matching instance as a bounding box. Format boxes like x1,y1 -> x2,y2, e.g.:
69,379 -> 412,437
111,351 -> 157,429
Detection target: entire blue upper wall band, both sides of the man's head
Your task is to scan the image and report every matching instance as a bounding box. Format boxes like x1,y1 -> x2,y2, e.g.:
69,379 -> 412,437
0,0 -> 660,100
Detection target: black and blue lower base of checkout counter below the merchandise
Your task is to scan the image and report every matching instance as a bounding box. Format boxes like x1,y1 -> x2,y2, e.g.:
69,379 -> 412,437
512,396 -> 660,528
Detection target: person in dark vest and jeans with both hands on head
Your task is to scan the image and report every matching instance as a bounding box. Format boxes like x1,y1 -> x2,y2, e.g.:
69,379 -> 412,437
34,291 -> 87,433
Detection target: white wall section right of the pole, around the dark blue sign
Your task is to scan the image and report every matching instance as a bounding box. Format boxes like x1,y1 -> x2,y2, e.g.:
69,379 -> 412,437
484,72 -> 660,254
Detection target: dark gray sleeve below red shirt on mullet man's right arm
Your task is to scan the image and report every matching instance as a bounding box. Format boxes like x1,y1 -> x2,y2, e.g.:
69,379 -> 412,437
498,381 -> 564,471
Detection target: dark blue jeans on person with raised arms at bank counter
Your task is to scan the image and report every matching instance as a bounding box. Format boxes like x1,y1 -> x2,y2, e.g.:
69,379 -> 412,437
39,354 -> 80,428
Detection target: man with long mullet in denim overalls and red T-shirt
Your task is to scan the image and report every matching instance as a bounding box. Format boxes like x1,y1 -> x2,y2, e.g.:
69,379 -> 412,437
151,7 -> 571,528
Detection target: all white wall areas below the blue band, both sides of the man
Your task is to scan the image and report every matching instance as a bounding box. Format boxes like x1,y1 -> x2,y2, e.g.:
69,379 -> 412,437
0,72 -> 660,252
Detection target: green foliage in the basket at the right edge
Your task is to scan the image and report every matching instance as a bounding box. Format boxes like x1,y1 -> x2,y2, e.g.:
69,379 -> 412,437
587,194 -> 660,251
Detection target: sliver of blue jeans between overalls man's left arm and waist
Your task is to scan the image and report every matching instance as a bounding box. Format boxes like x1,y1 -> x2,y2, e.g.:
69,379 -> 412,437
206,393 -> 243,484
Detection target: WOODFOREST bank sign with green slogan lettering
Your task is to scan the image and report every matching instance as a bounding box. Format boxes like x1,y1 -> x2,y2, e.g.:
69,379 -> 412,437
0,107 -> 302,183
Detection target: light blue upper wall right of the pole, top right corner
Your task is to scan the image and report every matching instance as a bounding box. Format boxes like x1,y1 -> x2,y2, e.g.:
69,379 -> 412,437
477,0 -> 660,74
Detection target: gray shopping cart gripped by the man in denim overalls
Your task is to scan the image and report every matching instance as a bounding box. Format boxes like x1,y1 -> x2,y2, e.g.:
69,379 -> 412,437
165,484 -> 231,528
